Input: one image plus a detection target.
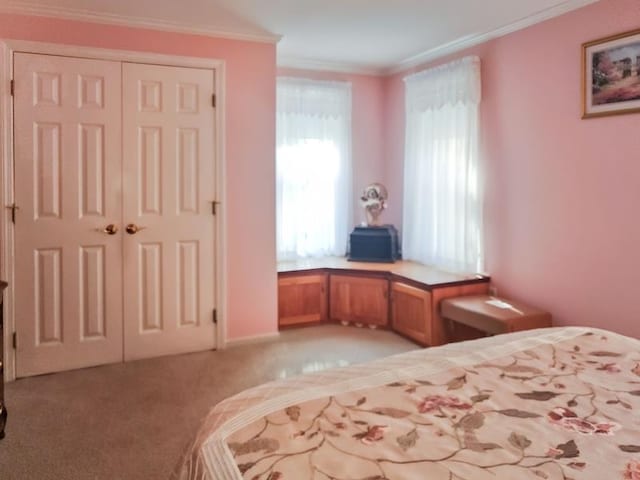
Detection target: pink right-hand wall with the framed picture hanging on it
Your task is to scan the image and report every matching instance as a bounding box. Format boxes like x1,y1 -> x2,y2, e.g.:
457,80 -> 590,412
386,0 -> 640,337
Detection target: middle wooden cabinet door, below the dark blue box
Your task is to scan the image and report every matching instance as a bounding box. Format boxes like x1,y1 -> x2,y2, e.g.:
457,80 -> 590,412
331,275 -> 389,326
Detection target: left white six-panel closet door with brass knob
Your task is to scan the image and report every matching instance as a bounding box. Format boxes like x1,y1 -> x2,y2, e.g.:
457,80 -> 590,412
12,53 -> 123,377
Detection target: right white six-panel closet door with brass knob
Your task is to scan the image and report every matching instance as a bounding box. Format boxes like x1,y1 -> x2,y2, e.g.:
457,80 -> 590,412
123,63 -> 216,359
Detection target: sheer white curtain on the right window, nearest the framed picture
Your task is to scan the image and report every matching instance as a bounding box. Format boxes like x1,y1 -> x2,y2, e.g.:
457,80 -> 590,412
402,57 -> 484,272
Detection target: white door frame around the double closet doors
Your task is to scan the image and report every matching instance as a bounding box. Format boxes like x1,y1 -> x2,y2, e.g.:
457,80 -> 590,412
0,40 -> 227,381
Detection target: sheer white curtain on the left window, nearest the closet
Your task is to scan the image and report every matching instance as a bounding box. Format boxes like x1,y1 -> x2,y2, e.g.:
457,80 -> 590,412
276,77 -> 352,260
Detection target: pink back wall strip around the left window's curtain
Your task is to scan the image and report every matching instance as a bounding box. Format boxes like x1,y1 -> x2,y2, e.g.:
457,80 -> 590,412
278,68 -> 384,224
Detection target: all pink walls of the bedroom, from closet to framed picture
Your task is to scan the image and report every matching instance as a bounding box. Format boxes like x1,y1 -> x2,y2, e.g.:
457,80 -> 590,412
6,0 -> 640,344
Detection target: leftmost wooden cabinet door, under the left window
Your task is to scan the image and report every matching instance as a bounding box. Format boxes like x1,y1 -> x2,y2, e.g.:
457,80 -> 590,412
278,274 -> 327,326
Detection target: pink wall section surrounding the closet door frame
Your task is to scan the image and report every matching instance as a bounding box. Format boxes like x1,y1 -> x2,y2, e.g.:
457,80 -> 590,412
0,14 -> 277,339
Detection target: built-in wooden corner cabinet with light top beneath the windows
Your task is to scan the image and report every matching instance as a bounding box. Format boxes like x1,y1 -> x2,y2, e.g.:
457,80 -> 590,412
278,259 -> 489,346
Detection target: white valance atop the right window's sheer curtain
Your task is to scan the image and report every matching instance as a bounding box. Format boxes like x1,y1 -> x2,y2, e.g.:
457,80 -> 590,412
404,56 -> 481,112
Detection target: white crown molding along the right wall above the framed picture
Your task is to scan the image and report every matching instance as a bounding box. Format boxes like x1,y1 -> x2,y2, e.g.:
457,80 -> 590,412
384,0 -> 600,75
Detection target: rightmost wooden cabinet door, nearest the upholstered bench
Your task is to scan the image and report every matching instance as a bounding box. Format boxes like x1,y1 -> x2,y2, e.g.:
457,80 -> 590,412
391,282 -> 431,345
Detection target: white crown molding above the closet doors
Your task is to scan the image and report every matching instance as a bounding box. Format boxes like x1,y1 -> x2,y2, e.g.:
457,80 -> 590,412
0,0 -> 281,43
